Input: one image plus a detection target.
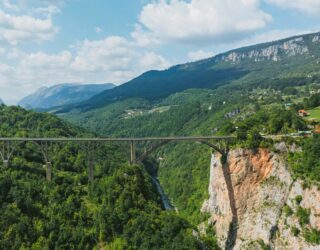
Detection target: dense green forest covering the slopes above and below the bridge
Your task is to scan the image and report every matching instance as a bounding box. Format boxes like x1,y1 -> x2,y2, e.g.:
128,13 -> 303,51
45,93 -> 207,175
4,31 -> 320,249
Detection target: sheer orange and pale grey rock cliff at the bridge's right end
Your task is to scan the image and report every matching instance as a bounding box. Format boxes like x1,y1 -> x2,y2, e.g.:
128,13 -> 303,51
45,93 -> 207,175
202,149 -> 320,249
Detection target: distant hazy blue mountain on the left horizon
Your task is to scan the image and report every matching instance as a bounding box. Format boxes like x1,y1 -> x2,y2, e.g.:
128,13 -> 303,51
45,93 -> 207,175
19,83 -> 115,109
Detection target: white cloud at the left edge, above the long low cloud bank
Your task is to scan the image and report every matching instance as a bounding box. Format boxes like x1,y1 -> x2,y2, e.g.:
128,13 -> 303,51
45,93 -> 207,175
0,10 -> 58,45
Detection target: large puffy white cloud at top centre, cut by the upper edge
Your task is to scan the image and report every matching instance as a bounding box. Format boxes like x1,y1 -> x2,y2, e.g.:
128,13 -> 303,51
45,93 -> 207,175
133,0 -> 272,44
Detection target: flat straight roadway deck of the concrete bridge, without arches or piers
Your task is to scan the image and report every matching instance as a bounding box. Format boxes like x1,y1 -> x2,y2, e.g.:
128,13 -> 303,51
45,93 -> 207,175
0,136 -> 235,142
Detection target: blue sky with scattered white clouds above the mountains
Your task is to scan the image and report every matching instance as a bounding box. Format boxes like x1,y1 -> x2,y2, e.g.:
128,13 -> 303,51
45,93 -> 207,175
0,0 -> 320,104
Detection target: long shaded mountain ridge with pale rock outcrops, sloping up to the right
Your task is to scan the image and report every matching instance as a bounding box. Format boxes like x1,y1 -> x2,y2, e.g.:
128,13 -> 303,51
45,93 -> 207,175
61,33 -> 320,112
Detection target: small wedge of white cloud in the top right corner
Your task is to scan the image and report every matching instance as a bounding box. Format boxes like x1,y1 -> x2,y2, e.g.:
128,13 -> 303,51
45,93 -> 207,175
266,0 -> 320,16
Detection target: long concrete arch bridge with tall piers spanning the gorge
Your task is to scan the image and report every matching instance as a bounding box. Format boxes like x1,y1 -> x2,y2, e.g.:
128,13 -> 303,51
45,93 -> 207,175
0,136 -> 235,182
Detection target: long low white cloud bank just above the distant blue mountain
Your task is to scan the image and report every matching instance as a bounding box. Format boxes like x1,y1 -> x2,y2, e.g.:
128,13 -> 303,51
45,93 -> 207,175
0,36 -> 170,103
